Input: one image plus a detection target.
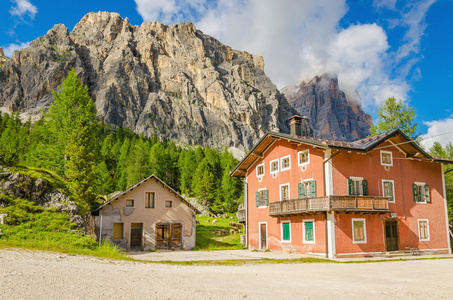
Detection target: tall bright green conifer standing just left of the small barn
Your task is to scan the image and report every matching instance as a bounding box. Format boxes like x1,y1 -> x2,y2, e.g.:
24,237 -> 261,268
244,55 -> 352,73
44,69 -> 99,210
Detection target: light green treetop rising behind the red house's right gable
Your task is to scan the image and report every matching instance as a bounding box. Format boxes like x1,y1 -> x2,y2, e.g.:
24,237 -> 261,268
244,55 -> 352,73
370,97 -> 420,140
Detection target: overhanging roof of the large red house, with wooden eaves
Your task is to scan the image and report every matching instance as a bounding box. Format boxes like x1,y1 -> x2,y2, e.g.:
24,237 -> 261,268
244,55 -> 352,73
230,129 -> 453,177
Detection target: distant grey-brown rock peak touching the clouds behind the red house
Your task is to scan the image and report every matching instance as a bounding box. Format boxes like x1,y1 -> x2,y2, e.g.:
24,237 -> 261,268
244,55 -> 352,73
282,74 -> 373,141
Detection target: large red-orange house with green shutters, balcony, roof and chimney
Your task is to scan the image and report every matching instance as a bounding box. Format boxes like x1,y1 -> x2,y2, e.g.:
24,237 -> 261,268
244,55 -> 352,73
231,116 -> 452,258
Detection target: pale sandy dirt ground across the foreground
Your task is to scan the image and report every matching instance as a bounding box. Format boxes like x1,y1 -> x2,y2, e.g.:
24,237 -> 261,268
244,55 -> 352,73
0,249 -> 453,299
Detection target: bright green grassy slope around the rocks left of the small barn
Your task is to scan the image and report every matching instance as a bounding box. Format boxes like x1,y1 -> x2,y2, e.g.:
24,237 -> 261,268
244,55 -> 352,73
0,167 -> 127,259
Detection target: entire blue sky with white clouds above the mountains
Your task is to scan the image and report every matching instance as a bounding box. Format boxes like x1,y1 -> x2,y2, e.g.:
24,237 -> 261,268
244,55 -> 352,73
0,0 -> 453,146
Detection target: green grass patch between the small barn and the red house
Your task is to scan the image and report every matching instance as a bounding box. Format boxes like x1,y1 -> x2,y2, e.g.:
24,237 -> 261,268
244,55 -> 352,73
192,216 -> 245,251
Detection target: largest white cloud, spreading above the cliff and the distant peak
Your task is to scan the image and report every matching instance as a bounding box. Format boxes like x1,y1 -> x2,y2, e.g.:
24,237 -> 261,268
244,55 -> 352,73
135,0 -> 435,107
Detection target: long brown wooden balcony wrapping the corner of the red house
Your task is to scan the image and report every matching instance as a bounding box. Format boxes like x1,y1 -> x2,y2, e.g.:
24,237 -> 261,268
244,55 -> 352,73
269,196 -> 390,217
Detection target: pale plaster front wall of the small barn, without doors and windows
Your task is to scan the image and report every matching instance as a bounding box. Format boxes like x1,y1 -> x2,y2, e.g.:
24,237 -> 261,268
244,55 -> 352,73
96,178 -> 195,249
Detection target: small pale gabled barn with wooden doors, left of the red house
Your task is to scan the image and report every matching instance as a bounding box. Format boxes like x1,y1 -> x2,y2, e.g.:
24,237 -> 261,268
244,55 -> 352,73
92,175 -> 199,250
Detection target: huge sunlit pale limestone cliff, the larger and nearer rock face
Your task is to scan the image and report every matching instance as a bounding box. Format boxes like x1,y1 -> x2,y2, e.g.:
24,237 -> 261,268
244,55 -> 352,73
0,12 -> 295,150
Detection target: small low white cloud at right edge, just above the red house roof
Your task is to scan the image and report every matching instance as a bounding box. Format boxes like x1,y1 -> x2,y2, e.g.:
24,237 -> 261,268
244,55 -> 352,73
422,116 -> 453,149
